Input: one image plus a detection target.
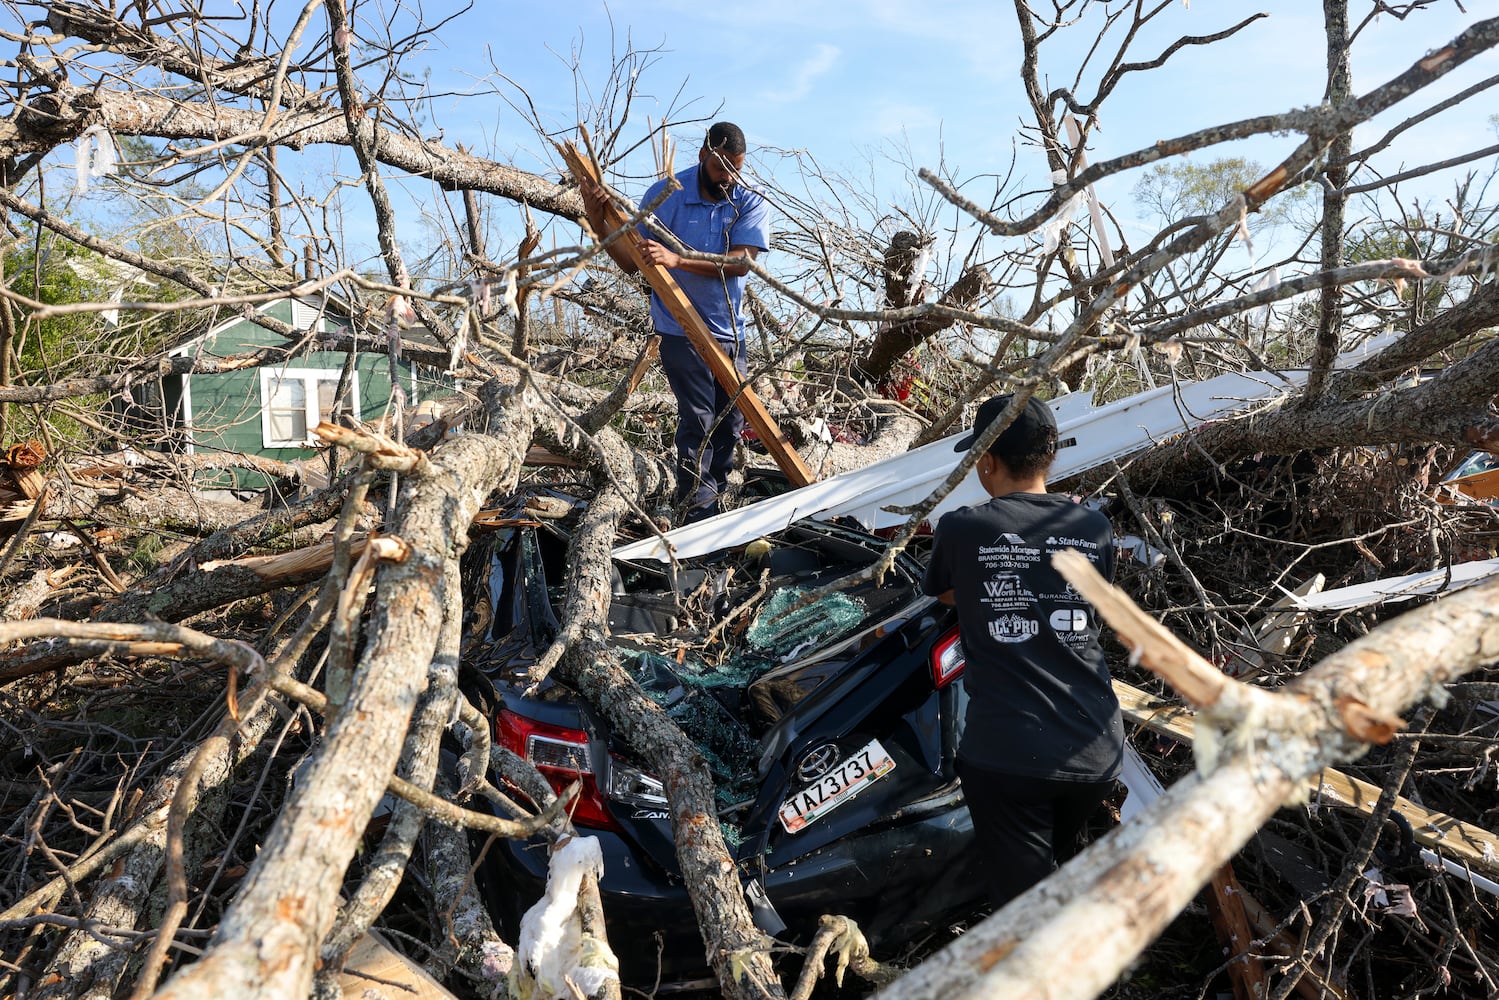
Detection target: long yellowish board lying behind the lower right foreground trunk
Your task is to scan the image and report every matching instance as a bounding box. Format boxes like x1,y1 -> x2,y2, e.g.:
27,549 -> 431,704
1114,681 -> 1499,876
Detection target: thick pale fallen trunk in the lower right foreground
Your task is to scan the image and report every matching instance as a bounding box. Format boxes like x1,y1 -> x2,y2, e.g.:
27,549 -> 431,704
880,566 -> 1499,1000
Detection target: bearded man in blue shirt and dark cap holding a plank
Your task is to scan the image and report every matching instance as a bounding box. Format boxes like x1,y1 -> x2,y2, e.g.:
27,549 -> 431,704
582,121 -> 770,523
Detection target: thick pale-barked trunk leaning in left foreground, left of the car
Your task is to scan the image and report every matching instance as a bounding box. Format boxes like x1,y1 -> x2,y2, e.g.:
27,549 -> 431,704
157,386 -> 531,999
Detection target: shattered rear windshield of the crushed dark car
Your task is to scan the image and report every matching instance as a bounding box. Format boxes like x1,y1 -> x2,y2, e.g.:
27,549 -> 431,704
610,528 -> 919,840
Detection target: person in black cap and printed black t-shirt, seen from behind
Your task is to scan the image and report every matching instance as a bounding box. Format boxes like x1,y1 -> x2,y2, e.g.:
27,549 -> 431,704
922,394 -> 1124,907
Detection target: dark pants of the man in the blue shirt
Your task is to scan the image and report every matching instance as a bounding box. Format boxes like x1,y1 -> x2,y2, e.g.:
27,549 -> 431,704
661,336 -> 745,522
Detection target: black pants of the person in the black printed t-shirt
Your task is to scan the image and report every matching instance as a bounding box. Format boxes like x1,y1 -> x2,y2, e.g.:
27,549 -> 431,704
958,760 -> 1114,910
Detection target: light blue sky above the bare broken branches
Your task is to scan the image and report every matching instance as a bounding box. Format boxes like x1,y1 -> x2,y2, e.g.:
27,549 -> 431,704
316,0 -> 1499,269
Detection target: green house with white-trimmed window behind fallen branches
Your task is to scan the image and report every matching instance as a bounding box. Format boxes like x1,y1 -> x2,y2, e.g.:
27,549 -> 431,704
132,298 -> 453,489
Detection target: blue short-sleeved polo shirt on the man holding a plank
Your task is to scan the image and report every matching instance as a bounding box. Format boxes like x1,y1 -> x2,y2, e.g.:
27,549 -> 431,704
640,163 -> 770,342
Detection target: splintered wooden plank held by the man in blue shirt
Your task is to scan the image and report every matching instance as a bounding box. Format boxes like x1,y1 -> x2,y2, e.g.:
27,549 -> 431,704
556,142 -> 815,486
